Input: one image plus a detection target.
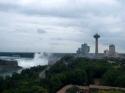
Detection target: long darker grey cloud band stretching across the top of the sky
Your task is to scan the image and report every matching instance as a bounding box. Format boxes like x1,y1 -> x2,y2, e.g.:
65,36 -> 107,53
0,2 -> 120,18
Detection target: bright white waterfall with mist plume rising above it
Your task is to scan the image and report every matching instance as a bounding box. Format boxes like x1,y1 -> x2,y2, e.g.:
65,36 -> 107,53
17,53 -> 48,68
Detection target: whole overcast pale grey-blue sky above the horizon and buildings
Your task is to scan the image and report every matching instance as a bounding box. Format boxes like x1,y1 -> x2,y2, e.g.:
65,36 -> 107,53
0,0 -> 125,53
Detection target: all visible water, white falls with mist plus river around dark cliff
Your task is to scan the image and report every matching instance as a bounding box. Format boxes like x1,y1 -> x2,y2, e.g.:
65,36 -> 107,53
0,53 -> 48,76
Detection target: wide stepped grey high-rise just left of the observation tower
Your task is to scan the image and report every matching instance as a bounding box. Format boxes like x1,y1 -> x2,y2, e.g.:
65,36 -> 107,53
77,43 -> 90,55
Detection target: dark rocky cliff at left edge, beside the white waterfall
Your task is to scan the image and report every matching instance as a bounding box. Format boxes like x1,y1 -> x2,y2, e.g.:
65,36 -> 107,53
0,59 -> 21,73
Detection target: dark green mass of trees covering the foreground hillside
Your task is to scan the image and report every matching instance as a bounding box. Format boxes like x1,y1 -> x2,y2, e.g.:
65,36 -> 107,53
0,56 -> 125,93
